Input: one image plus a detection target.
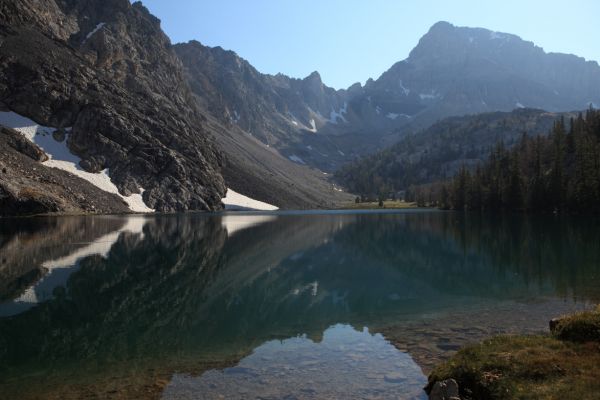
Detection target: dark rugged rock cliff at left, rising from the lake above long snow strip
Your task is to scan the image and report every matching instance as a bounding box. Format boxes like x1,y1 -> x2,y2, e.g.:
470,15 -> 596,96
0,0 -> 225,211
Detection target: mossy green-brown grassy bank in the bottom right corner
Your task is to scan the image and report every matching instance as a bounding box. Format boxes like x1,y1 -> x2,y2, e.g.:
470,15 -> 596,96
428,309 -> 600,400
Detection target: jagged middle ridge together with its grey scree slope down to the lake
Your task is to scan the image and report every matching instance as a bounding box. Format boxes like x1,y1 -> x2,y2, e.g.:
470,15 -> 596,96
173,41 -> 350,209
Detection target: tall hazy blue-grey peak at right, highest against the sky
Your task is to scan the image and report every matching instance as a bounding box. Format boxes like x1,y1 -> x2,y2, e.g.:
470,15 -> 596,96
356,22 -> 600,127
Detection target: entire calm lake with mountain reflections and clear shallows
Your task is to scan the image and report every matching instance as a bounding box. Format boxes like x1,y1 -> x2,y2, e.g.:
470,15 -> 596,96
0,210 -> 600,399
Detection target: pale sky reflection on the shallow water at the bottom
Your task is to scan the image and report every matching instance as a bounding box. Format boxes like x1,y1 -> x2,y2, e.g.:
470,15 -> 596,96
163,325 -> 427,400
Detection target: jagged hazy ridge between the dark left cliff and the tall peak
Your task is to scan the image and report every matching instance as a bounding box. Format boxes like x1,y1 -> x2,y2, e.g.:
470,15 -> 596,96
174,41 -> 345,145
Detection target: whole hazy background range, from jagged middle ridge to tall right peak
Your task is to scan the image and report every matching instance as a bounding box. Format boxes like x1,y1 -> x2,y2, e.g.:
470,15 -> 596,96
175,22 -> 600,171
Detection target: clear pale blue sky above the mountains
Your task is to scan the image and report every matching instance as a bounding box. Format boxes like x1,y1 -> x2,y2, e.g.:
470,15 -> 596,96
138,0 -> 600,88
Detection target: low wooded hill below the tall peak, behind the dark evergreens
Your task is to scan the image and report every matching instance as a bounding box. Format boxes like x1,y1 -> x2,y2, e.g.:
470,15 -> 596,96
335,109 -> 577,195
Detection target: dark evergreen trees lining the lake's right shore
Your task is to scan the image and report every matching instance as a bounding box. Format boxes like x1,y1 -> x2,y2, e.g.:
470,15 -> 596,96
422,109 -> 600,213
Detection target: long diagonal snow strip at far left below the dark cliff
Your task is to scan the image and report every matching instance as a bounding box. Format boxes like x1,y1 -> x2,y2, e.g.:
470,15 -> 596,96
0,111 -> 154,212
